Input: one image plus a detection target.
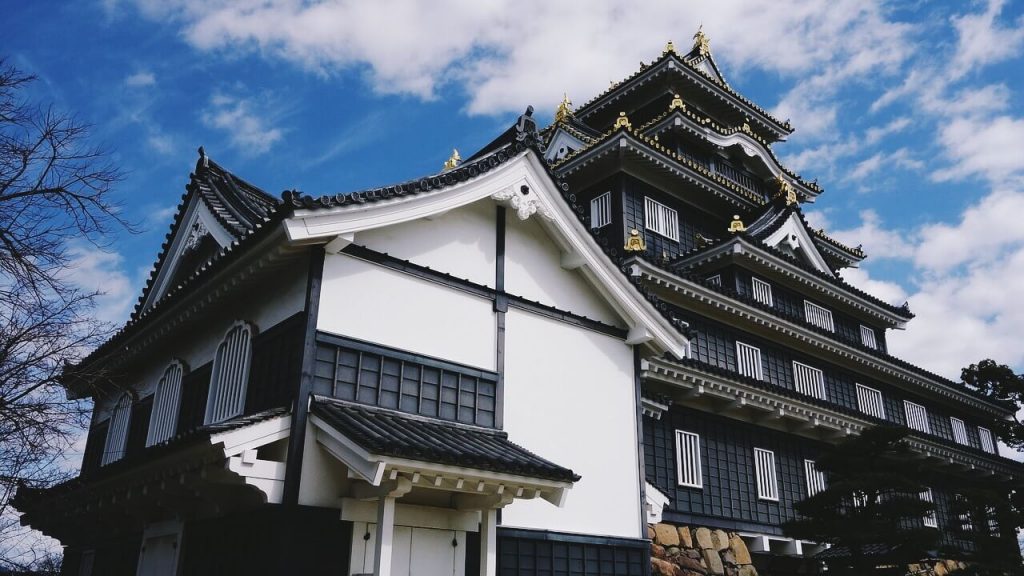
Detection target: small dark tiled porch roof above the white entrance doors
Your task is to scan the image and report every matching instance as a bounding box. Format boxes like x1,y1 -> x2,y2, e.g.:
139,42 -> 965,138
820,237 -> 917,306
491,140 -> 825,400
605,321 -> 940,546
310,397 -> 580,482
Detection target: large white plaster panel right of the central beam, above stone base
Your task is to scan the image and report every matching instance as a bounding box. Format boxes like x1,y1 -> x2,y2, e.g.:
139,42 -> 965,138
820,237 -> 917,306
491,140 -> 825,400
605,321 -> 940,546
502,310 -> 642,538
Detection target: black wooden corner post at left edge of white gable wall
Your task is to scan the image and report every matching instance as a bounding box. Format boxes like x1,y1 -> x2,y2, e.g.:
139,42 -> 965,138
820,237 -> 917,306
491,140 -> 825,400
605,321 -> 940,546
282,245 -> 325,505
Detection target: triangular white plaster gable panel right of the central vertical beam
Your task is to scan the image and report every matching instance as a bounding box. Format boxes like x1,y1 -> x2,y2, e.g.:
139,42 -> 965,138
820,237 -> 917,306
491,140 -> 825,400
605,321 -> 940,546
505,211 -> 622,326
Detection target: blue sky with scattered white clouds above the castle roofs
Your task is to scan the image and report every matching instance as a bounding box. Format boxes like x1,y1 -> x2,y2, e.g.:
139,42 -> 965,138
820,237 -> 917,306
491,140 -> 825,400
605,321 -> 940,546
6,0 -> 1024,377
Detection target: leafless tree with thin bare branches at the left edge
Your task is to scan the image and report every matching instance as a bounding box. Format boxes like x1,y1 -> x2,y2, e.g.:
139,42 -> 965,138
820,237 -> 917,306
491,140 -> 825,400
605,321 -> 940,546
0,59 -> 131,570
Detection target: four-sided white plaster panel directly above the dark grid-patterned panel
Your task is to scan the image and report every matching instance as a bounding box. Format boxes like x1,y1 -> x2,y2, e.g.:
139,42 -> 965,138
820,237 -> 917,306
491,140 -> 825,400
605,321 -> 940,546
316,254 -> 496,370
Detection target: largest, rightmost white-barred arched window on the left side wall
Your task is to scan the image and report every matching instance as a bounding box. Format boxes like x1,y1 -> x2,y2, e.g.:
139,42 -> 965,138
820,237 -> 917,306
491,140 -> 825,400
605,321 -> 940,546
205,322 -> 253,424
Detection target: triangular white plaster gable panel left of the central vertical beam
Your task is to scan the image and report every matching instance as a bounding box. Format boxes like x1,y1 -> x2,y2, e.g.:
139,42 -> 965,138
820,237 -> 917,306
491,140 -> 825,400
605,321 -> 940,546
355,200 -> 497,288
